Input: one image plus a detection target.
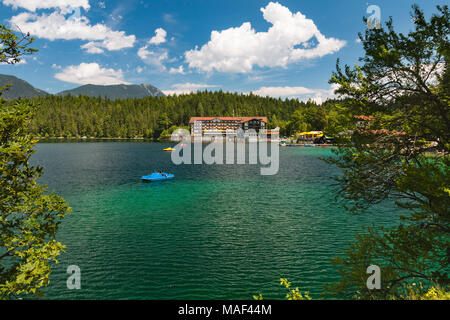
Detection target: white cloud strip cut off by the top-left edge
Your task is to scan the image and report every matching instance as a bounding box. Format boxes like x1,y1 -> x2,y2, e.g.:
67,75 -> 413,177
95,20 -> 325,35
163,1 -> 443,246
2,0 -> 90,11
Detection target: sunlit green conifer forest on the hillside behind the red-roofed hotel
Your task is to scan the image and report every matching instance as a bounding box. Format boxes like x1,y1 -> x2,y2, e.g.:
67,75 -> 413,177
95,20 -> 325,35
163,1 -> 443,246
15,91 -> 350,139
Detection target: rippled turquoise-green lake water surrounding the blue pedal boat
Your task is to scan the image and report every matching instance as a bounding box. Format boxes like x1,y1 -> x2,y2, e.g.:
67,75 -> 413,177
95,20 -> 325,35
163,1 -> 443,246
32,142 -> 399,299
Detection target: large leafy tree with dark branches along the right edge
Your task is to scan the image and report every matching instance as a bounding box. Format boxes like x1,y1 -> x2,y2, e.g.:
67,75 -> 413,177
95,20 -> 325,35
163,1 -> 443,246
327,6 -> 450,299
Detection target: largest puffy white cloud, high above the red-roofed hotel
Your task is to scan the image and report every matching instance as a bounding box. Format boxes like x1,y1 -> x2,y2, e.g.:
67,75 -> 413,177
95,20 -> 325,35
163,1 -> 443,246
185,2 -> 346,73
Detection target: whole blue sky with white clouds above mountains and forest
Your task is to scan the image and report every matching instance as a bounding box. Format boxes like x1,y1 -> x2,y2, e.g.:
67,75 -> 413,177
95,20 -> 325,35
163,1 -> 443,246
0,0 -> 446,101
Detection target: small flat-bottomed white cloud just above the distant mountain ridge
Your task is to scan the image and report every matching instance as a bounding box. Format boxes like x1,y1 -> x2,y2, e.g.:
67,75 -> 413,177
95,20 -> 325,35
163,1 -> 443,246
55,62 -> 128,85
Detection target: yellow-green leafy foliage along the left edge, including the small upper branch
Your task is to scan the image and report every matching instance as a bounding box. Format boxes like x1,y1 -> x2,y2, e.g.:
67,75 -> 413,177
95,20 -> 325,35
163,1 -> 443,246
0,25 -> 70,300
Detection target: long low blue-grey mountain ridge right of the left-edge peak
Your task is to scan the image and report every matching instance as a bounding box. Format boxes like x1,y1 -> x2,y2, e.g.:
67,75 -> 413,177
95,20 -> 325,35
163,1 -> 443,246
57,84 -> 165,100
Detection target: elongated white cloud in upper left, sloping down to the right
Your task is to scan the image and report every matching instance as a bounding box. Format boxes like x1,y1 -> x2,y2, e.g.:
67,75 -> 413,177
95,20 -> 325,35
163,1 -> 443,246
10,11 -> 136,53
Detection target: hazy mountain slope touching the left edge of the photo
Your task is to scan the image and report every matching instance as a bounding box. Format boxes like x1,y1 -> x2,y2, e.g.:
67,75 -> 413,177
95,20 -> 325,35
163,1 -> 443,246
0,74 -> 48,100
